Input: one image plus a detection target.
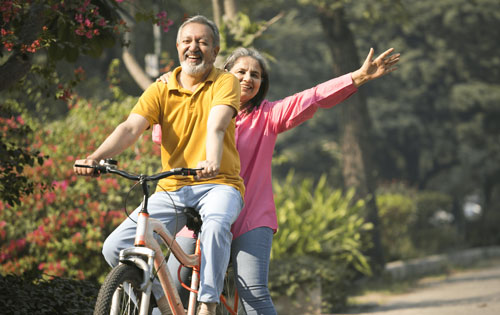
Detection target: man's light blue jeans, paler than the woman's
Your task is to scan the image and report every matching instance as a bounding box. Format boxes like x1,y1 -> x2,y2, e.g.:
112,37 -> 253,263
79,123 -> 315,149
102,184 -> 243,303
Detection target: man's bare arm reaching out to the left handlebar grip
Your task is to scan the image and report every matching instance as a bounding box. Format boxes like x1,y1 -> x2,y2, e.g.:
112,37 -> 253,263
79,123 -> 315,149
73,113 -> 149,176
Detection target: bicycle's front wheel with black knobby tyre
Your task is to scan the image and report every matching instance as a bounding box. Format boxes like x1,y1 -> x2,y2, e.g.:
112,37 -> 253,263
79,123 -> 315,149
94,264 -> 152,315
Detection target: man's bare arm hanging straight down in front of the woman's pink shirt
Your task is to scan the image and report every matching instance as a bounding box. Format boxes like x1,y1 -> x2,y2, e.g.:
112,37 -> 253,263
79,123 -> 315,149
197,105 -> 236,178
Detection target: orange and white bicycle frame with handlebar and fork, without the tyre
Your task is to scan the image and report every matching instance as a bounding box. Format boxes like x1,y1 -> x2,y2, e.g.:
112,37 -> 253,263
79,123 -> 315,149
75,160 -> 238,315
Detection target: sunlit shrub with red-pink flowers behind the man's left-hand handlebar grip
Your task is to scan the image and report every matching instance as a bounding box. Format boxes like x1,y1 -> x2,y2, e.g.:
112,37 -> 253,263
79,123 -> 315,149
0,86 -> 161,280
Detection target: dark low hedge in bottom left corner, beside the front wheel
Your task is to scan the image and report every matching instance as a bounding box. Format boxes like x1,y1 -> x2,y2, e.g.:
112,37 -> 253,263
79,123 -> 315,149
0,273 -> 99,315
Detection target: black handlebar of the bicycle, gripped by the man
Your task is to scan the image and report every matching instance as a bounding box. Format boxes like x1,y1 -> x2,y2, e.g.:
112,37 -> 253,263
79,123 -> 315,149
75,160 -> 202,182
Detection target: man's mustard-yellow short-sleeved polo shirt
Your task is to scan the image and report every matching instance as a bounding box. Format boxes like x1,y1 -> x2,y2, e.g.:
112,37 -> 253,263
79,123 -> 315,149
132,67 -> 245,196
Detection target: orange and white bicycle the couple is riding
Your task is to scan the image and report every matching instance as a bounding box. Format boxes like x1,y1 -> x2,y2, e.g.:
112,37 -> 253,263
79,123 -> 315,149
75,159 -> 238,315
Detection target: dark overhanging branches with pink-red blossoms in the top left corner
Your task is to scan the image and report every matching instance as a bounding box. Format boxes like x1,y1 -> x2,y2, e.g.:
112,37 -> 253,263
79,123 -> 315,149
0,0 -> 126,91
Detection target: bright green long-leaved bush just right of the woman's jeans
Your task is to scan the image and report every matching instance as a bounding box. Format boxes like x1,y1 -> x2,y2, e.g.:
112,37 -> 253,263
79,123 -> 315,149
270,172 -> 371,309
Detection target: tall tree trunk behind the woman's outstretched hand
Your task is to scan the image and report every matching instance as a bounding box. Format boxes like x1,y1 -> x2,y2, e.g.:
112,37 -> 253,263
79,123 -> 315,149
318,7 -> 385,273
